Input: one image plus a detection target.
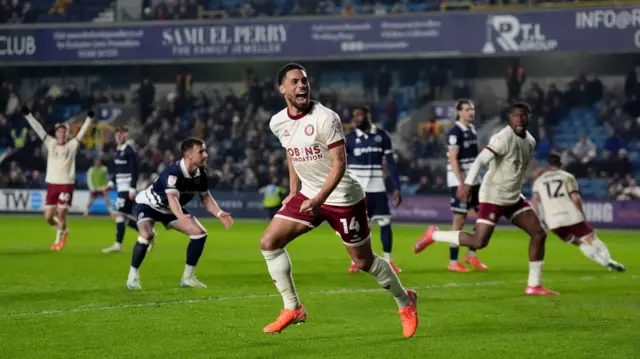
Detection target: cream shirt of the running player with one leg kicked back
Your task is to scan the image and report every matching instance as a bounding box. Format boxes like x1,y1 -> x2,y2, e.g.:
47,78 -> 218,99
480,126 -> 536,206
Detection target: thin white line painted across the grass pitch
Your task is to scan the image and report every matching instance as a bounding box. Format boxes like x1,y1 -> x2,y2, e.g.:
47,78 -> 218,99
0,275 -> 640,318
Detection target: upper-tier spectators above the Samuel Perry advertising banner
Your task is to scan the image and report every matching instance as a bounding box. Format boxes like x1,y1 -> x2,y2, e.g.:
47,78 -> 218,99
0,0 -> 592,23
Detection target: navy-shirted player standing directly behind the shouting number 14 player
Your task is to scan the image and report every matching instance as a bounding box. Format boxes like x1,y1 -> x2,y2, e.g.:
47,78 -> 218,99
346,107 -> 402,273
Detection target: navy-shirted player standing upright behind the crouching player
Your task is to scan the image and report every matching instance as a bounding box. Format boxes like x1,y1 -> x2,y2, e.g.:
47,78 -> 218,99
102,126 -> 138,253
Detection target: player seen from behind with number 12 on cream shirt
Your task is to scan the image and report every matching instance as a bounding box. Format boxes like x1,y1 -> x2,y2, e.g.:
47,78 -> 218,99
531,153 -> 625,272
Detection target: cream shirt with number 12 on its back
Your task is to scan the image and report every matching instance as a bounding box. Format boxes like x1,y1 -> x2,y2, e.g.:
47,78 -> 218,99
533,170 -> 584,229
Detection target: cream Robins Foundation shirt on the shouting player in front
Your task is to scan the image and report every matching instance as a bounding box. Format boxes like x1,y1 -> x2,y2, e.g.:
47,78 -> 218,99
269,101 -> 365,207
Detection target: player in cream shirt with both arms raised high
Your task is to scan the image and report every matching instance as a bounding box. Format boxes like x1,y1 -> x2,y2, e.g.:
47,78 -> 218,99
22,107 -> 93,251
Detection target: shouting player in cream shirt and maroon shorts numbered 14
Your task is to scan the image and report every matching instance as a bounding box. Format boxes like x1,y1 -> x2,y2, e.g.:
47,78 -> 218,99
260,64 -> 418,338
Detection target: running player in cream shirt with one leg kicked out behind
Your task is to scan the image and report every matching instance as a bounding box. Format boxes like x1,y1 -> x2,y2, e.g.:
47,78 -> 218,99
416,102 -> 558,295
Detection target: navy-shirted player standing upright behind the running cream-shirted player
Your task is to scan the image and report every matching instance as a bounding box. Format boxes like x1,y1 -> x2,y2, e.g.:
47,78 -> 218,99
414,99 -> 487,272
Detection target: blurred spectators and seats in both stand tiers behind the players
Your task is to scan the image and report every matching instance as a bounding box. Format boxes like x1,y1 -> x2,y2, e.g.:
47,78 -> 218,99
0,0 -> 640,200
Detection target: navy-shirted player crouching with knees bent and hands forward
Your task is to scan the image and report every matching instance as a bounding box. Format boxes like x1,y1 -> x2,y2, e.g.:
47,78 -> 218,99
127,138 -> 233,289
